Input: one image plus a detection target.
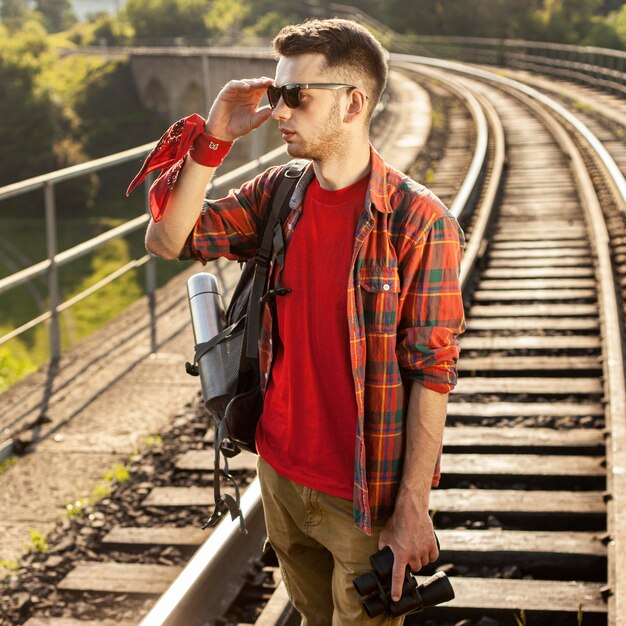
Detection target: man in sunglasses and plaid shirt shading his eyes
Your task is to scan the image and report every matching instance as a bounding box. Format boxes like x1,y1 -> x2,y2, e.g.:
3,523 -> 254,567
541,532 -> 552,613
146,19 -> 464,626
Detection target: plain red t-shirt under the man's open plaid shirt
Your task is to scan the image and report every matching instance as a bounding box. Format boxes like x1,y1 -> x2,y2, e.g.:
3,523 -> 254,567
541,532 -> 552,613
256,174 -> 369,499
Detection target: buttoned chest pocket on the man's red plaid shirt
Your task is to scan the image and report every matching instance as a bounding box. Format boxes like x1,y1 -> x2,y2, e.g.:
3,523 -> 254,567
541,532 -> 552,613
359,267 -> 400,334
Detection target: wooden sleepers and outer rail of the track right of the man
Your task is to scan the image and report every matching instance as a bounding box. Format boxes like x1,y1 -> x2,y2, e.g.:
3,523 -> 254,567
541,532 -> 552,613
398,59 -> 624,624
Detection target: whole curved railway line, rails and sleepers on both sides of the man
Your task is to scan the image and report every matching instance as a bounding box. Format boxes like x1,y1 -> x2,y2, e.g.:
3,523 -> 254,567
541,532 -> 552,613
2,55 -> 626,626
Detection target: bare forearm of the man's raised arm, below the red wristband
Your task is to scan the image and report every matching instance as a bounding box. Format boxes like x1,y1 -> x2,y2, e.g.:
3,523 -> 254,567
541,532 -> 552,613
146,157 -> 216,259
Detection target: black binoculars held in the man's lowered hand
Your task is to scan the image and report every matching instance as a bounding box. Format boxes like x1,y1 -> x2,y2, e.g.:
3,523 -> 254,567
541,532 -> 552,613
353,546 -> 454,617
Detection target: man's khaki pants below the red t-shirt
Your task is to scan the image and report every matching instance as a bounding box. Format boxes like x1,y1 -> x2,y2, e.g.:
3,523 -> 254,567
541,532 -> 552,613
258,457 -> 404,626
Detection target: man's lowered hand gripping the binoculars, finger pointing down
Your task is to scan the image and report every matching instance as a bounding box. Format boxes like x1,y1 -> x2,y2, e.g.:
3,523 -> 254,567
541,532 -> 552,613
378,499 -> 439,602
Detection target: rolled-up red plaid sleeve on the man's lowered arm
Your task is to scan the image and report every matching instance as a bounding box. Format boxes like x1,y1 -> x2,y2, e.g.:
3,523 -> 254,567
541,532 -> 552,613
396,215 -> 465,393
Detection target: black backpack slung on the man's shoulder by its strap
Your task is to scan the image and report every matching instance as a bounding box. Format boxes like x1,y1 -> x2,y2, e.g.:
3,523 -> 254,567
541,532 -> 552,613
186,160 -> 310,532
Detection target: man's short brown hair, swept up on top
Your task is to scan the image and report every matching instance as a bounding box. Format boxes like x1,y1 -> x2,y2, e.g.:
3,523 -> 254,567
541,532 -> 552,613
272,18 -> 388,120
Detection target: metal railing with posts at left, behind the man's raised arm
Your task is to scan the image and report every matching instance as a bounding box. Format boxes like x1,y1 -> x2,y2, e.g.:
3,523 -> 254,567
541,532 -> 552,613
0,142 -> 285,359
